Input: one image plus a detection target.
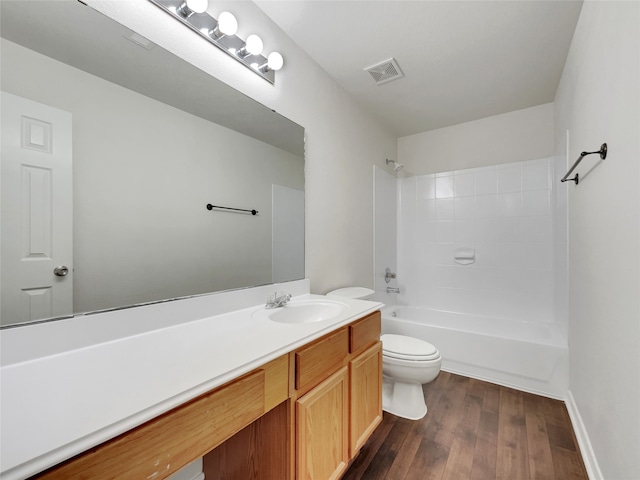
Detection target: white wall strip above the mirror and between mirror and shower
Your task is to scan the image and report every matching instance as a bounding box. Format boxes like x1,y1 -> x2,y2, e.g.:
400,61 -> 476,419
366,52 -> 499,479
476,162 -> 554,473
88,0 -> 396,293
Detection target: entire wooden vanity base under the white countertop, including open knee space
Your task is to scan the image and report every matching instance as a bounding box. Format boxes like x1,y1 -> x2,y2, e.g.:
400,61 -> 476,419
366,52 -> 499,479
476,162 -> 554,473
33,312 -> 382,480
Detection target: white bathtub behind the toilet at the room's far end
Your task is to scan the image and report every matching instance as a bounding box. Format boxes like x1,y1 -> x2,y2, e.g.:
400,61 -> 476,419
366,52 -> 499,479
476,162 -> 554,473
382,306 -> 569,400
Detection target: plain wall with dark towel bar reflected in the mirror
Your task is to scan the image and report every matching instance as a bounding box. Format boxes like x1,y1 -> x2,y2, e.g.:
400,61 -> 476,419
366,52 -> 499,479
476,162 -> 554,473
2,39 -> 304,312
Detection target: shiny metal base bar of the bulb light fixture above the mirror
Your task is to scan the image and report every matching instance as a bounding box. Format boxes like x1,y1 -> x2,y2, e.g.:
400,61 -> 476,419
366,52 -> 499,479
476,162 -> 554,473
149,0 -> 276,84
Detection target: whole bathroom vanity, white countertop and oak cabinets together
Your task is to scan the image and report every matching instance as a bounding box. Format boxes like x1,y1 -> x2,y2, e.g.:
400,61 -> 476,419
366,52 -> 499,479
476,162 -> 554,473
2,284 -> 382,480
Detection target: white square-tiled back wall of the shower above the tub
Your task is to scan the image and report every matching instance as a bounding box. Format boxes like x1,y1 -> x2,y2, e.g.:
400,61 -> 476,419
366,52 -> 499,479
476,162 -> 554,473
398,158 -> 555,322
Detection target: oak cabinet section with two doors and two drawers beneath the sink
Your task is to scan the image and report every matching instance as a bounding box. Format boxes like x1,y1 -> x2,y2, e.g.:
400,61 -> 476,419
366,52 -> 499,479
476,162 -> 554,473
295,312 -> 382,480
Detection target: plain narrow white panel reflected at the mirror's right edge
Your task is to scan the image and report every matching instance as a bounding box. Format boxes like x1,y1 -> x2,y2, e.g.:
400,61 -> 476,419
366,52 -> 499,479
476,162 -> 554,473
271,185 -> 304,283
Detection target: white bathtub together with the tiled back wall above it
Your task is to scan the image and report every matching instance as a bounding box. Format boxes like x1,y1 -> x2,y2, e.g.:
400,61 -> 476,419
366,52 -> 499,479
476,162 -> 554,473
383,158 -> 568,399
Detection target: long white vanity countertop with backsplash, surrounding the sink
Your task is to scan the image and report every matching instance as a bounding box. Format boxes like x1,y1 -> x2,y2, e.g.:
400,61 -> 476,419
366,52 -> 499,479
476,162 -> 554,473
0,288 -> 382,480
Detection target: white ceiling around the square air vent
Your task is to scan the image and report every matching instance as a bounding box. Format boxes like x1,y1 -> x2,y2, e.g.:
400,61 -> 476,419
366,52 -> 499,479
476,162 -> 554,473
256,0 -> 582,137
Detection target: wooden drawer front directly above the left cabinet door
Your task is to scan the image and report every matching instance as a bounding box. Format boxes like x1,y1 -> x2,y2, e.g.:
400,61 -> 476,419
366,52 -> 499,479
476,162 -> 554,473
295,328 -> 349,394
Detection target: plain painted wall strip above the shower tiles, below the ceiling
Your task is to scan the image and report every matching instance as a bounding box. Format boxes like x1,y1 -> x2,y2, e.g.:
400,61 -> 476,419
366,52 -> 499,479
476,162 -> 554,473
398,103 -> 553,175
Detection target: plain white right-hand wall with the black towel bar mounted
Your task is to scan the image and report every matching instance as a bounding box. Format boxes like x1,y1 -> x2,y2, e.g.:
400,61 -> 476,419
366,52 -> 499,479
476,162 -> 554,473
555,1 -> 640,479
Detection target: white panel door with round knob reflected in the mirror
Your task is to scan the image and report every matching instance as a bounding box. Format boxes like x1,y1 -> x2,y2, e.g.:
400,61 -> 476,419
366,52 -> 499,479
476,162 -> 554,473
0,92 -> 73,325
